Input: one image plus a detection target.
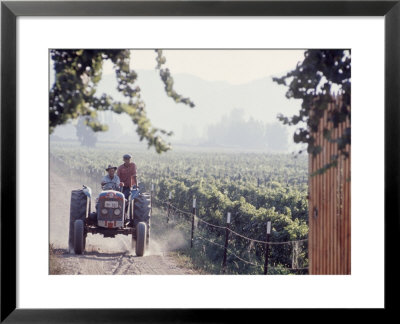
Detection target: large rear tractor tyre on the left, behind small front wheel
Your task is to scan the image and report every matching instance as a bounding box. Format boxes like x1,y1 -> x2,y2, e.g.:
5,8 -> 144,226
68,189 -> 90,252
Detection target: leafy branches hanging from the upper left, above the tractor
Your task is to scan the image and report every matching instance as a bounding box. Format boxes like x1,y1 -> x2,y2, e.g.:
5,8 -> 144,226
49,49 -> 194,153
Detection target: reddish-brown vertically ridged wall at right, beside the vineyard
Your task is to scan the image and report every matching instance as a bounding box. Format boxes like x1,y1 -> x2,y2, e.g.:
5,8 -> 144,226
308,98 -> 351,274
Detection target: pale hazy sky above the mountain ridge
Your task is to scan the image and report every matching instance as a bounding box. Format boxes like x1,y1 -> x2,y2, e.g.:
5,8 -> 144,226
103,50 -> 304,84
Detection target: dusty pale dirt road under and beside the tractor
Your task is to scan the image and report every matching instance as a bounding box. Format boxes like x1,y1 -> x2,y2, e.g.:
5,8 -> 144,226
50,168 -> 196,275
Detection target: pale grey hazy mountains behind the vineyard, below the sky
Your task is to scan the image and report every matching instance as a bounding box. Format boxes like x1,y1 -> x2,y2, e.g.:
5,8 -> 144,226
50,70 -> 300,152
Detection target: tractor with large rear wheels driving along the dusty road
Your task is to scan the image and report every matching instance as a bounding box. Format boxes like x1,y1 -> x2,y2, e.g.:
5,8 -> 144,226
68,184 -> 151,256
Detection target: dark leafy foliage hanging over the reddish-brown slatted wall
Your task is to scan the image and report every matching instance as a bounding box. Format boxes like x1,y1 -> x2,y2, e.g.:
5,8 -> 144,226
273,50 -> 351,174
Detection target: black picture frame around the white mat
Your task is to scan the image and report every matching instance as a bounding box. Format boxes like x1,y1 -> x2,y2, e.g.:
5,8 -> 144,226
0,0 -> 400,323
